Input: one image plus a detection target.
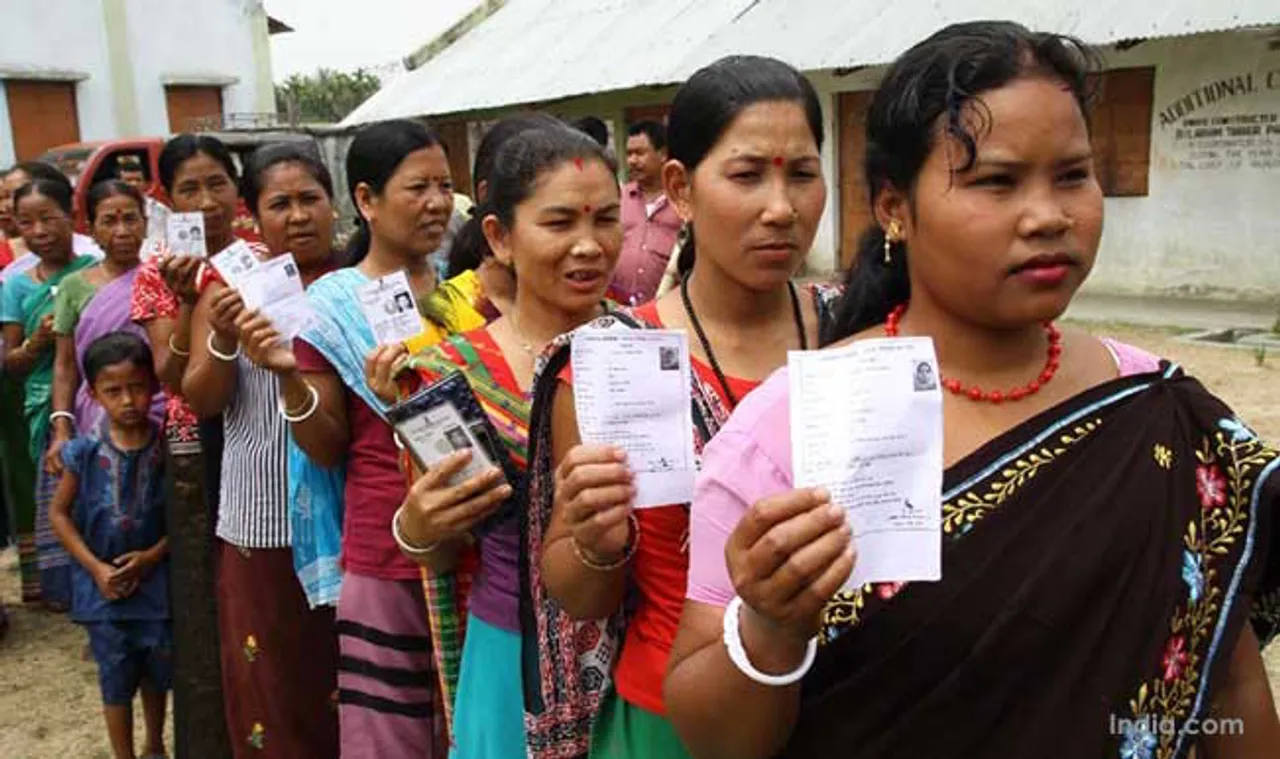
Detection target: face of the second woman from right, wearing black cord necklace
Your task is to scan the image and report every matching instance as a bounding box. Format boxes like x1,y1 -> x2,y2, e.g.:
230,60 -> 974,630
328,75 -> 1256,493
664,101 -> 827,291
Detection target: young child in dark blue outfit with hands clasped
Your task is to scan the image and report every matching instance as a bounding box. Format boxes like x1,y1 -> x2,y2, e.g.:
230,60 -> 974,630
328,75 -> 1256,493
49,332 -> 172,759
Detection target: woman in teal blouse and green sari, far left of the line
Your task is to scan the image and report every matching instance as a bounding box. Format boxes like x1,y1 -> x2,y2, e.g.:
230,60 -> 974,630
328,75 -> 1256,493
0,178 -> 96,611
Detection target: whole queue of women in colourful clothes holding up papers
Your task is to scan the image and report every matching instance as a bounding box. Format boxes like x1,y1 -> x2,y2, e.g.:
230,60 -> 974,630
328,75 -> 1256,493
0,16 -> 1280,759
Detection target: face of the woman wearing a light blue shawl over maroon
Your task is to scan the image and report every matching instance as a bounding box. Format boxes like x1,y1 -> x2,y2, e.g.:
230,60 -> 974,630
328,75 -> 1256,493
356,145 -> 453,259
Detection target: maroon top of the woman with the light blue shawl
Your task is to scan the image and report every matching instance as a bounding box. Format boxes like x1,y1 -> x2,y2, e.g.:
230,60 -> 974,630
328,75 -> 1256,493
293,339 -> 422,580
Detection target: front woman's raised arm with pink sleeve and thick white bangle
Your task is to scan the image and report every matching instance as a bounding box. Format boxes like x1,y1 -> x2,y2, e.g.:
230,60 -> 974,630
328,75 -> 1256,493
663,430 -> 855,759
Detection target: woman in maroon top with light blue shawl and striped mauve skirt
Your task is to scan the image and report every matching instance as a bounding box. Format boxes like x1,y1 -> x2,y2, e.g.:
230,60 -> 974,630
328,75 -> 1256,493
244,120 -> 484,759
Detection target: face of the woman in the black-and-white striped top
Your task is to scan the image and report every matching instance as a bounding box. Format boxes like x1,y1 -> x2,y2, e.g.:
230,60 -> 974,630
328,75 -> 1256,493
256,163 -> 333,268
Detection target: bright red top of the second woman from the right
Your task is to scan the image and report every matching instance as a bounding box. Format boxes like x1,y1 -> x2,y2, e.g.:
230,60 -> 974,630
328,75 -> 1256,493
559,302 -> 760,714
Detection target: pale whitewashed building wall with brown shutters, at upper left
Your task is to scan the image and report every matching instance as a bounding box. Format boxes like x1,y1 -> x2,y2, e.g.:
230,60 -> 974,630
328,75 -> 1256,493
0,0 -> 274,163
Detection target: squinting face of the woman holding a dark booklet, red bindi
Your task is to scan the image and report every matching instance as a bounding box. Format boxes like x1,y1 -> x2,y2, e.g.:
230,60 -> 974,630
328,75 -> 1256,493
484,159 -> 622,314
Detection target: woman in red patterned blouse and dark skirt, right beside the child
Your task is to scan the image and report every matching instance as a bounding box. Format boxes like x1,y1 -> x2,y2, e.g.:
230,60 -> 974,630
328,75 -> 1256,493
129,134 -> 254,756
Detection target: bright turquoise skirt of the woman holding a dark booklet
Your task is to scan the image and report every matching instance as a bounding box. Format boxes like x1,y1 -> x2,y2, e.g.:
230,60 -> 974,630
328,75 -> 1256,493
449,614 -> 529,759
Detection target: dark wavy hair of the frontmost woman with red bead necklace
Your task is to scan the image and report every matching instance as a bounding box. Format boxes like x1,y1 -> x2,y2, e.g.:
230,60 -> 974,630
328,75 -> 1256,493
823,22 -> 1096,343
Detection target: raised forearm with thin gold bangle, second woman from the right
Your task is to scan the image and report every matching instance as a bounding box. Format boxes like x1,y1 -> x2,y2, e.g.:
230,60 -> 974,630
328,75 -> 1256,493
541,381 -> 640,619
